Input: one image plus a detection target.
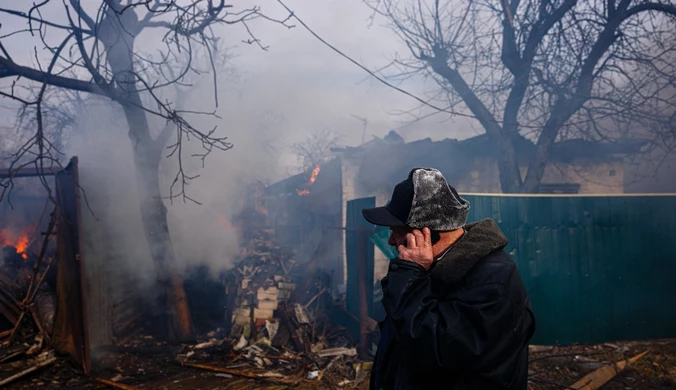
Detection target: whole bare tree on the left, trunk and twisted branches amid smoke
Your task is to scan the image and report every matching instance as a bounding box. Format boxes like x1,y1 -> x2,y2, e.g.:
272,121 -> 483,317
0,0 -> 290,339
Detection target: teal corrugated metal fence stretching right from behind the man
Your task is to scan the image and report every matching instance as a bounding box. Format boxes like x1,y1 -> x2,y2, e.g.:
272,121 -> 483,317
462,194 -> 676,344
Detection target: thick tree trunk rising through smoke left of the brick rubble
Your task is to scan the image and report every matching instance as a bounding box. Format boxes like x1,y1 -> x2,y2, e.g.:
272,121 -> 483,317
98,8 -> 192,341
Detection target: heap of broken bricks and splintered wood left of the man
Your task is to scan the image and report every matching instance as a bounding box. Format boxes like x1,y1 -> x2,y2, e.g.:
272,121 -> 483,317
173,228 -> 371,387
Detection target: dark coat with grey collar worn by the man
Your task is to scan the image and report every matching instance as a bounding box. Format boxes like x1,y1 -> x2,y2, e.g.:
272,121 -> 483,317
371,219 -> 535,390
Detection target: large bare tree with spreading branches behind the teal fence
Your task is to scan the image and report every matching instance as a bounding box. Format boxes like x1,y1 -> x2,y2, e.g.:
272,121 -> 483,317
366,0 -> 676,193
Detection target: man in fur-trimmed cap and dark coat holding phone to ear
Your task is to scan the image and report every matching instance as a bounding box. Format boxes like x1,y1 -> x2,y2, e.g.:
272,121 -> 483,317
363,168 -> 535,390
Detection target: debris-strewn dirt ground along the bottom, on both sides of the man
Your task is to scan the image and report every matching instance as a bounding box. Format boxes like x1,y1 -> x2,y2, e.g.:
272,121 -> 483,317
0,340 -> 676,390
